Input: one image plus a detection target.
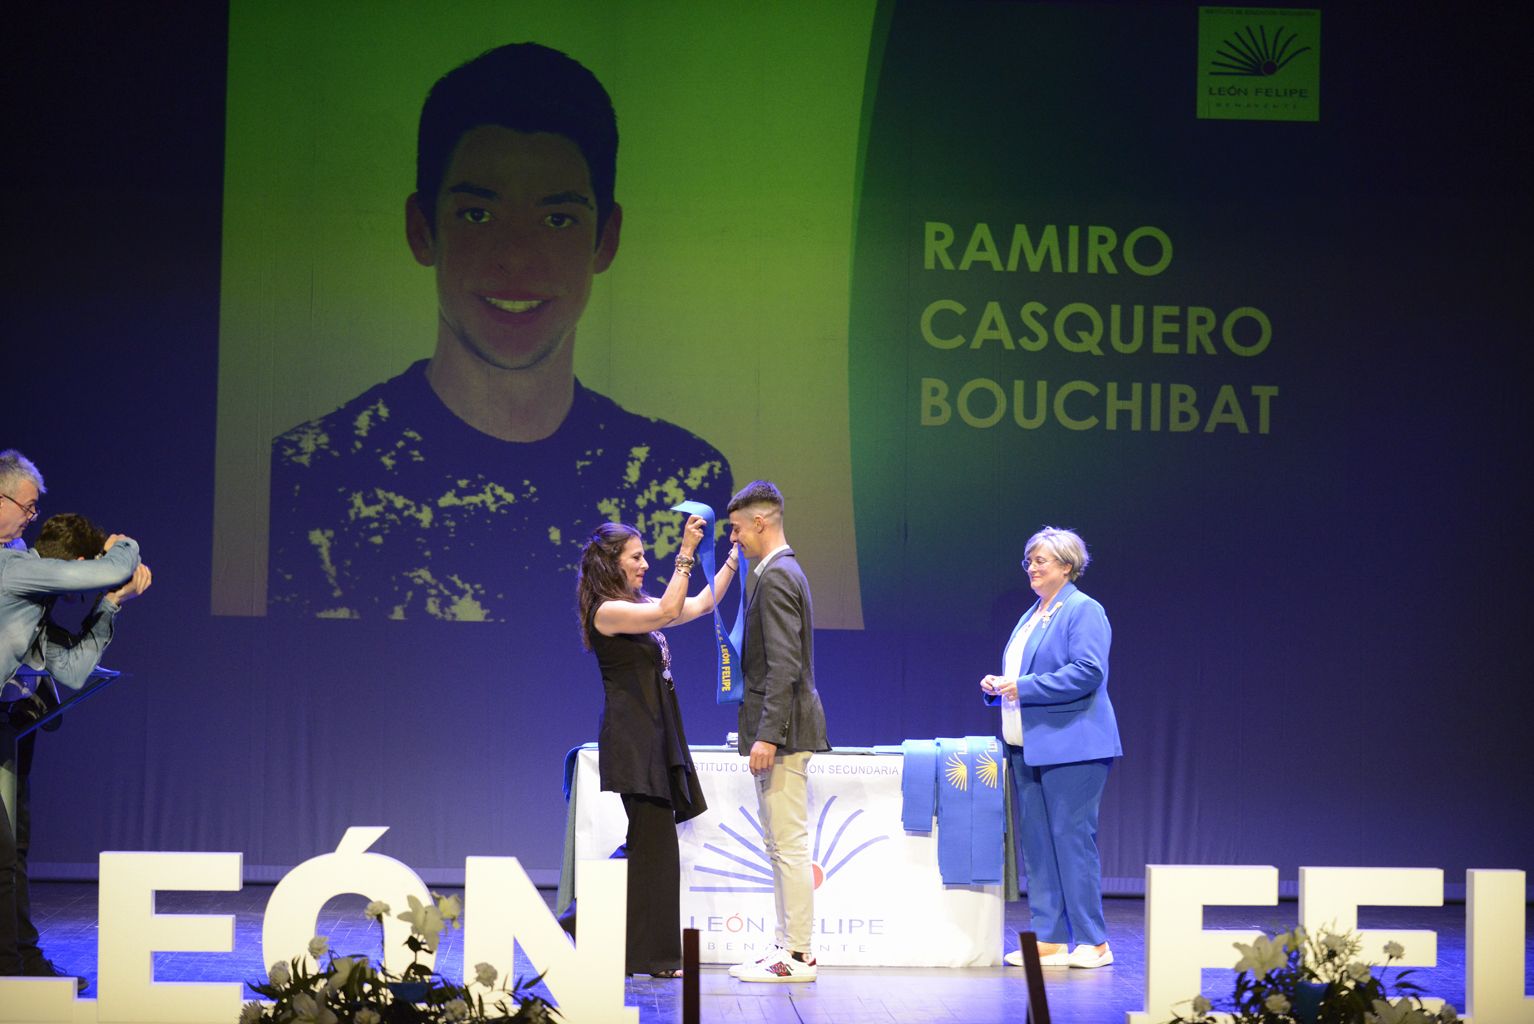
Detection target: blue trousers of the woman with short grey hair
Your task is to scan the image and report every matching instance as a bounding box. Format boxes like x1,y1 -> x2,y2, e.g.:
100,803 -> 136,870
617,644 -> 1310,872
1006,745 -> 1112,946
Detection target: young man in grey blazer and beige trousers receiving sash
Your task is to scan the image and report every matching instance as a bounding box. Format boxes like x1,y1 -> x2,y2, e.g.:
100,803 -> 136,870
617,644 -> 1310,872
729,480 -> 831,981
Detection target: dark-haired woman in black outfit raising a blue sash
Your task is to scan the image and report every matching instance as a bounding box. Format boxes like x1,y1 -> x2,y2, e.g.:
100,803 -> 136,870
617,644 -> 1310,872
577,515 -> 736,978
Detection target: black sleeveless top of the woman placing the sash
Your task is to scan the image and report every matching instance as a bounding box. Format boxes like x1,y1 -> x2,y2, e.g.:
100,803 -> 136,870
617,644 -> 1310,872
586,609 -> 709,822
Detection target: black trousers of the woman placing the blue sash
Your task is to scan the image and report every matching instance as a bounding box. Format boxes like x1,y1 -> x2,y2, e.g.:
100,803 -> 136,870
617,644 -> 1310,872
621,793 -> 681,975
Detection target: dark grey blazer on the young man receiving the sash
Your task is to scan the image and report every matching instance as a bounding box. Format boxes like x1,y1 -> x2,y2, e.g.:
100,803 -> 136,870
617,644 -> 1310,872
739,549 -> 831,754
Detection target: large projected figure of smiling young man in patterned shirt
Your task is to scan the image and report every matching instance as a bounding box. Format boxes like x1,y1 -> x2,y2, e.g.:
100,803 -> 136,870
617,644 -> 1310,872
267,43 -> 730,621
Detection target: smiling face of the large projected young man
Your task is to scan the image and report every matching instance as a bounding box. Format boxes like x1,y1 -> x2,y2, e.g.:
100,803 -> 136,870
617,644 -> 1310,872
407,124 -> 621,369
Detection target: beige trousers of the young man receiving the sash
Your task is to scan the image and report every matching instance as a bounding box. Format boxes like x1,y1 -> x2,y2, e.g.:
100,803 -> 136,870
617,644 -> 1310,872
756,750 -> 815,953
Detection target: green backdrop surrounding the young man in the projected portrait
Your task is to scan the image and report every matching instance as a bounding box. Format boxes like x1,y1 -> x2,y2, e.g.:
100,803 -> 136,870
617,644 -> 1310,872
213,2 -> 874,629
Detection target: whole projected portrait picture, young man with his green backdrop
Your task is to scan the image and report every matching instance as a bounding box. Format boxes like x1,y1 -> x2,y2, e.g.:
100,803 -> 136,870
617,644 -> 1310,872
212,3 -> 871,635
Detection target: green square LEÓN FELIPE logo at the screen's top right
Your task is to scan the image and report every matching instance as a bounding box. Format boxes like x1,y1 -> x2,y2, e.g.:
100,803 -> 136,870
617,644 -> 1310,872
1198,8 -> 1321,121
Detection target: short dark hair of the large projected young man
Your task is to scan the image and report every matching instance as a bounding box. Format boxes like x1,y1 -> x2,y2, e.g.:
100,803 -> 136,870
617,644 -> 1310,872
416,43 -> 618,238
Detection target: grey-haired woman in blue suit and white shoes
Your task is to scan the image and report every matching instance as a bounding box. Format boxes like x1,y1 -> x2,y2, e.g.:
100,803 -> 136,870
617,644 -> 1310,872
980,526 -> 1123,967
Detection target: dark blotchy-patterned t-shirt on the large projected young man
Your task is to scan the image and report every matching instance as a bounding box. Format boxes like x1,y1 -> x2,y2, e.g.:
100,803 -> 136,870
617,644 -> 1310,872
267,360 -> 730,622
